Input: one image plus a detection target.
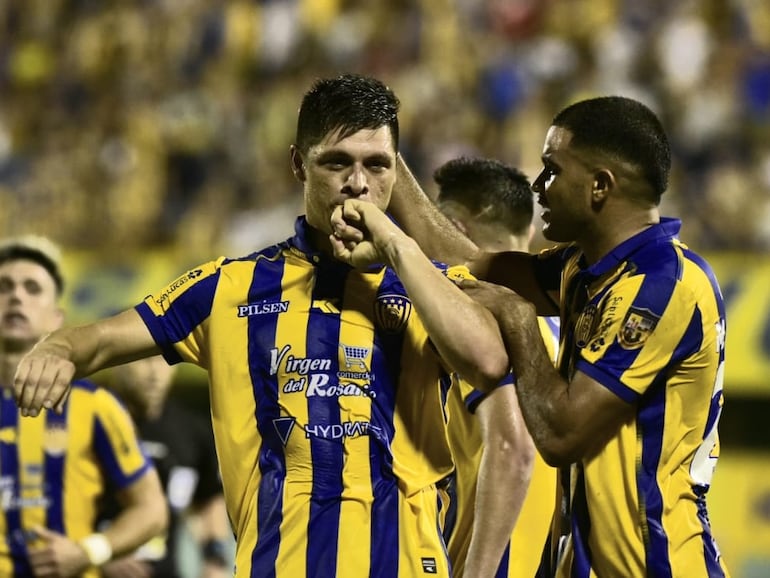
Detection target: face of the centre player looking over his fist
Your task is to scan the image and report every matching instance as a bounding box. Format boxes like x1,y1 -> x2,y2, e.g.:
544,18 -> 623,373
303,126 -> 396,235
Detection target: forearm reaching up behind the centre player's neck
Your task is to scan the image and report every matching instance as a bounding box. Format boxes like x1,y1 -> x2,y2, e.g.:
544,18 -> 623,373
388,155 -> 479,265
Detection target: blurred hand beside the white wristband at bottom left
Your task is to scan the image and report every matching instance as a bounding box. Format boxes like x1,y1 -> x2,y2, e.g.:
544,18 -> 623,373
29,527 -> 90,578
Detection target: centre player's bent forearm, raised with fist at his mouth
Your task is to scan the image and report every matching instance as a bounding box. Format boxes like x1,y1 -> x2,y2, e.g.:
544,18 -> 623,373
386,235 -> 509,390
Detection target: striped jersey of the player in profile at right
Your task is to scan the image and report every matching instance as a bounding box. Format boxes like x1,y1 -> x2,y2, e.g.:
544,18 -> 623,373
535,219 -> 728,578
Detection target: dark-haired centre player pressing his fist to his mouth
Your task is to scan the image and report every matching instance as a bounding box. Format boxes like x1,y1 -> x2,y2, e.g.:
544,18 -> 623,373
10,75 -> 510,578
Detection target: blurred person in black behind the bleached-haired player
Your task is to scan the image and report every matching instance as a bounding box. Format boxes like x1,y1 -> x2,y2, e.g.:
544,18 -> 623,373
100,355 -> 232,578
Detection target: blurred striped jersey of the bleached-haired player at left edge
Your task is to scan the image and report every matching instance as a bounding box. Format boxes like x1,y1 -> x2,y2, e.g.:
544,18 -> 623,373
0,381 -> 150,578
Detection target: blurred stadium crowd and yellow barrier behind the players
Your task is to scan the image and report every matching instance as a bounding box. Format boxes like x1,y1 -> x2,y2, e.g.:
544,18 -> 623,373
0,0 -> 770,578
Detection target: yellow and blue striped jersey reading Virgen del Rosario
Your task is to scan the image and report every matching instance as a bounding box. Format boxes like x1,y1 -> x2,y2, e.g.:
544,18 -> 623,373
137,217 -> 456,578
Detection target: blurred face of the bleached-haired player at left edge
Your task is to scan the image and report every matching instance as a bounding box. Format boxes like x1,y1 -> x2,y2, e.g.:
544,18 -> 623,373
0,259 -> 63,352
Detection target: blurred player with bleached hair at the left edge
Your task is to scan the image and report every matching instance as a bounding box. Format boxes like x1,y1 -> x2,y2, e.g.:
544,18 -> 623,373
0,237 -> 166,578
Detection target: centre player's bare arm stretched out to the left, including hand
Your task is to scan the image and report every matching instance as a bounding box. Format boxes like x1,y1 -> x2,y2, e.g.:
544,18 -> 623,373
14,309 -> 160,416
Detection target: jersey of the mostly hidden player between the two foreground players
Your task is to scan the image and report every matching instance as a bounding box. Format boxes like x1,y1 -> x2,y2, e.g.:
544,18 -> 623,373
444,317 -> 559,578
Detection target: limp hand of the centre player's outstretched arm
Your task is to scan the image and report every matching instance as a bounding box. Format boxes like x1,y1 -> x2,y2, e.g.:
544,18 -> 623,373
13,342 -> 75,417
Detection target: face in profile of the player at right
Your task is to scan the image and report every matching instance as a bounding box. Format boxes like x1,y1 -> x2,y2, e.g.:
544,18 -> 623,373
532,126 -> 594,242
